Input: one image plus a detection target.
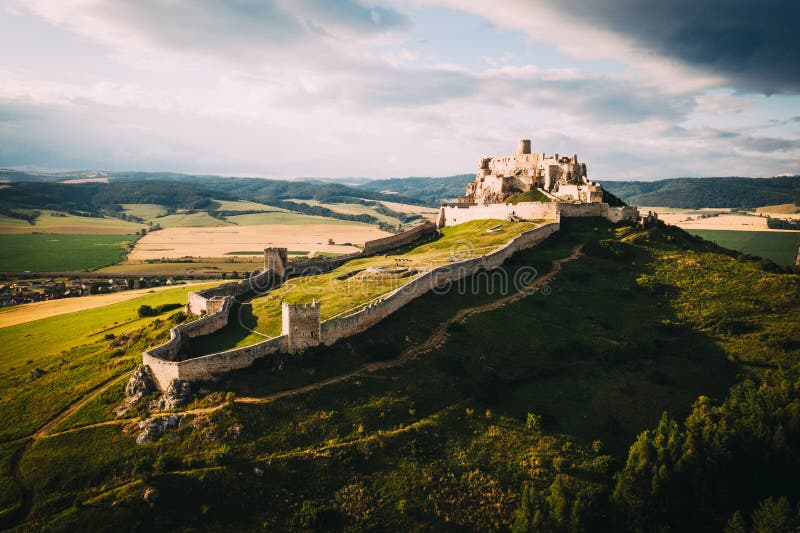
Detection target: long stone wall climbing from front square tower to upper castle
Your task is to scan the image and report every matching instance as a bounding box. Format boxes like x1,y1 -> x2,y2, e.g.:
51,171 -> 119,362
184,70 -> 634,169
321,222 -> 560,346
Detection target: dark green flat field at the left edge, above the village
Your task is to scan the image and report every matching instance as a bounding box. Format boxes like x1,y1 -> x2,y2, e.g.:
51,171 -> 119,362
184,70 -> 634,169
0,234 -> 133,272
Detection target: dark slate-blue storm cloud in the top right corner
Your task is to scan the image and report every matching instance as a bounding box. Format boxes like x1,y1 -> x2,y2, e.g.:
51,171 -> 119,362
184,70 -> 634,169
554,0 -> 800,94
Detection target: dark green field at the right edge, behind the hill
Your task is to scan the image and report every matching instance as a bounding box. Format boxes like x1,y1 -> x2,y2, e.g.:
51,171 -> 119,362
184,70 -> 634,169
686,229 -> 800,266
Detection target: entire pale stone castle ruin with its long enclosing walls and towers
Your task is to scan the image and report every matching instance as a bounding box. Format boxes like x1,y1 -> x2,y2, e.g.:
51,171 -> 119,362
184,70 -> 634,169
136,139 -> 639,390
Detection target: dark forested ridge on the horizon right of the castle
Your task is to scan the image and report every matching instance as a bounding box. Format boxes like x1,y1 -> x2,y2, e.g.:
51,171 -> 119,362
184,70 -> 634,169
600,176 -> 800,209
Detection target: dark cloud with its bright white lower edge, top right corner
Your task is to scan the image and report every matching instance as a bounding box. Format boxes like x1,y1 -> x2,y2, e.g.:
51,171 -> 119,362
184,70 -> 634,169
429,0 -> 800,94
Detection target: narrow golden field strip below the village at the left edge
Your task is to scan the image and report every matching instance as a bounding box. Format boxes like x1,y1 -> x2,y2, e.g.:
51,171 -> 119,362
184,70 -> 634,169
0,282 -> 208,328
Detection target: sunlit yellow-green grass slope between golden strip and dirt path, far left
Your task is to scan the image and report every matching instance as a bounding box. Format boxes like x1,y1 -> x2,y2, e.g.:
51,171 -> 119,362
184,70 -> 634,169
0,278 -> 215,442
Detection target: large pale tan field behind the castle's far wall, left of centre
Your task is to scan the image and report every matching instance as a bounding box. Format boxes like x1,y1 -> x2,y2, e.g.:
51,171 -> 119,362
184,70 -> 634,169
128,222 -> 389,261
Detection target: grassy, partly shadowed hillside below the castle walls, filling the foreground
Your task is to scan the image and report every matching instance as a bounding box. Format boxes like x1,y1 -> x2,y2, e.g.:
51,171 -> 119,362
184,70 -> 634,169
0,219 -> 800,531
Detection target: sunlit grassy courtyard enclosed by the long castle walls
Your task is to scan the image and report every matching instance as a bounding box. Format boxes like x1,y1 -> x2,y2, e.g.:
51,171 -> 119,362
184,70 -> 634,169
195,220 -> 545,353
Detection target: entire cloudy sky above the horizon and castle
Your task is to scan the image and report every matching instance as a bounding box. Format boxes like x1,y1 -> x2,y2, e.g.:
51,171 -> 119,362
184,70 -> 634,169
0,0 -> 800,180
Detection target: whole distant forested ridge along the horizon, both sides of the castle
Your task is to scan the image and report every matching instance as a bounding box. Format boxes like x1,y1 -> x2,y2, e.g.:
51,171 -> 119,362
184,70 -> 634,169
0,169 -> 800,209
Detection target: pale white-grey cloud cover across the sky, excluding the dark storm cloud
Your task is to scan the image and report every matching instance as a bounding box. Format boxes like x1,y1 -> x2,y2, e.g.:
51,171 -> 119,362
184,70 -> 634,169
0,0 -> 798,177
